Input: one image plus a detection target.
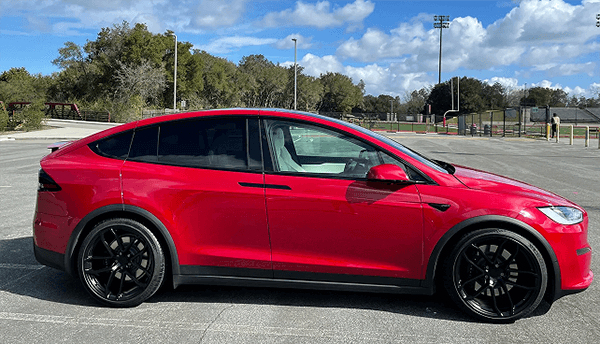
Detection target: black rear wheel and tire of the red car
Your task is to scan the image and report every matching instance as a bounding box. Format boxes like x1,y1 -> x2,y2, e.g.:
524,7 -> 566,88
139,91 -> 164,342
77,218 -> 165,307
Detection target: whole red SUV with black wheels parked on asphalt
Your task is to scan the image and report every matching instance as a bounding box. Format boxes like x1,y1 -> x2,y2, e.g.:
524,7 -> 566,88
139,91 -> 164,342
33,109 -> 593,322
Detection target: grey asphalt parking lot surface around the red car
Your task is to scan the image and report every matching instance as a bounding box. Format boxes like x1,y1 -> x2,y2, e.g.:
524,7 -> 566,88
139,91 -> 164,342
0,134 -> 600,343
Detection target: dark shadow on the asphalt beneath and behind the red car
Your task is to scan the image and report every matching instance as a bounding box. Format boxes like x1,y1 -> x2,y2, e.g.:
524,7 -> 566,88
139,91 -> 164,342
0,237 -> 549,322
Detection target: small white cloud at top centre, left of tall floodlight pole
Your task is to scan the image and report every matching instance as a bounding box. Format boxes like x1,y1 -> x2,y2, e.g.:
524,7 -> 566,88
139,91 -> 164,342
262,0 -> 375,30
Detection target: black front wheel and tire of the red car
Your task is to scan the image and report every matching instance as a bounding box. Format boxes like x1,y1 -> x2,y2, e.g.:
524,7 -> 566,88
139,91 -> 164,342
443,229 -> 548,323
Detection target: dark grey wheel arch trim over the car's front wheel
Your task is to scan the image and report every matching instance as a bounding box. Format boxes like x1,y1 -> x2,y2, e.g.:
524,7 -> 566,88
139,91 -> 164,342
422,215 -> 561,303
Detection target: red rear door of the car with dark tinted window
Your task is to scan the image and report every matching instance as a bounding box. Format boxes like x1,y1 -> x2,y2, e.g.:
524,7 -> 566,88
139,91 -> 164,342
123,116 -> 272,277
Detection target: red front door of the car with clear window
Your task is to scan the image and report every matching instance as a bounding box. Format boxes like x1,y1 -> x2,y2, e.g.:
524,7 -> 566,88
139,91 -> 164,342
264,120 -> 423,283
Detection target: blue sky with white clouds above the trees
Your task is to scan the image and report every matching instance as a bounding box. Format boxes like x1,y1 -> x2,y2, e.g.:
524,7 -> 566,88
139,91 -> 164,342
0,0 -> 600,97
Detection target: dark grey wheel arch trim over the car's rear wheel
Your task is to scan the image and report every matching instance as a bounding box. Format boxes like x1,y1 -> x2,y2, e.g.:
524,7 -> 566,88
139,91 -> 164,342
65,204 -> 179,277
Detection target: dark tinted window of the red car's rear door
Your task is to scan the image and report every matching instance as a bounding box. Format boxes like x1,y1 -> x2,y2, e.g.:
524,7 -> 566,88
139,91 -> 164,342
158,118 -> 248,169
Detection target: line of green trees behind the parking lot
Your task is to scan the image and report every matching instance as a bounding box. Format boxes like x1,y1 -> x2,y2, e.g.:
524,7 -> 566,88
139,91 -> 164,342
0,22 -> 599,124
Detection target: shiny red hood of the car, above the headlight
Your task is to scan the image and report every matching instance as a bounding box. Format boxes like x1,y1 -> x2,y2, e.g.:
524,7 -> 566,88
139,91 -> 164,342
454,166 -> 575,205
